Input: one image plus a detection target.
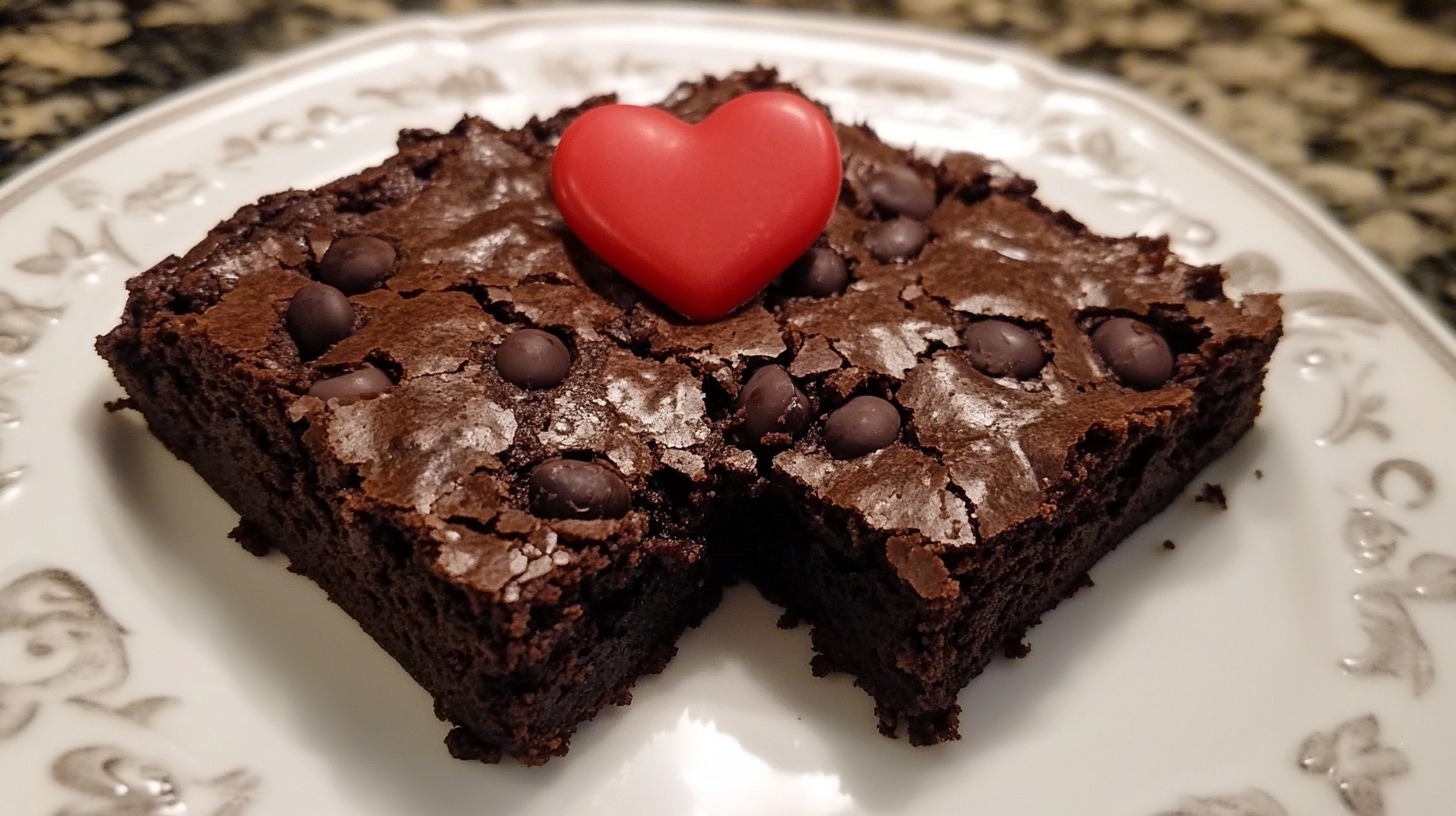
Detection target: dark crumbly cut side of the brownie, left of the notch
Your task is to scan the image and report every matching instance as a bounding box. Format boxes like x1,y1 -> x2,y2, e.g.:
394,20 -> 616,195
102,294 -> 719,765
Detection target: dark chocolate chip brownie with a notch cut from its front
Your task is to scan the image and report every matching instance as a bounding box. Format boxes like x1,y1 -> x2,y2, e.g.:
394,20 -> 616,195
99,70 -> 1280,764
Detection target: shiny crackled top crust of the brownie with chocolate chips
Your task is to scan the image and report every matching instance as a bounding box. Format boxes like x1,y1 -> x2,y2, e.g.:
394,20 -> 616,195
132,70 -> 1278,597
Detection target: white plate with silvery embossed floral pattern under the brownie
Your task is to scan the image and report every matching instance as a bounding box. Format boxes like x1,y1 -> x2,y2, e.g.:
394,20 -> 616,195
0,7 -> 1456,816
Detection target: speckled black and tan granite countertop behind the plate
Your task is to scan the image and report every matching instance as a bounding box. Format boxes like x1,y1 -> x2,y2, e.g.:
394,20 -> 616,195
8,0 -> 1456,325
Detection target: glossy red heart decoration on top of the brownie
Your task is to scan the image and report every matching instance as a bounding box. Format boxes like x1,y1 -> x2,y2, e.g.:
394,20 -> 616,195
552,90 -> 840,321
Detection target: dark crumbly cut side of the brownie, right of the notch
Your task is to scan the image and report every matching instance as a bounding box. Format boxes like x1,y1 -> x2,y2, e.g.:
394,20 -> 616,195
719,311 -> 1277,745
